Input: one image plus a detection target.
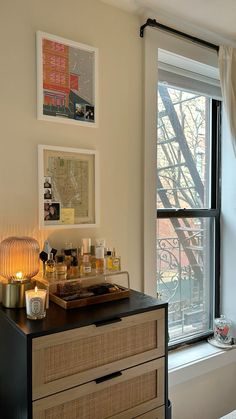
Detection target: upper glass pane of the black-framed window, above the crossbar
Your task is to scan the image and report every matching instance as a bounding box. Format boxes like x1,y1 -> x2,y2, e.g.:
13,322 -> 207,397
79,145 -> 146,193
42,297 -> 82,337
157,83 -> 211,209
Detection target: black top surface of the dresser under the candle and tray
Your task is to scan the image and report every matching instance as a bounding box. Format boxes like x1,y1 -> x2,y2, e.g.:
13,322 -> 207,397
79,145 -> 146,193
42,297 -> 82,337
0,290 -> 167,338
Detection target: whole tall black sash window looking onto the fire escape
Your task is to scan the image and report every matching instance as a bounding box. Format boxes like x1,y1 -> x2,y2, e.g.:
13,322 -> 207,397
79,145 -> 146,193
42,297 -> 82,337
156,58 -> 221,345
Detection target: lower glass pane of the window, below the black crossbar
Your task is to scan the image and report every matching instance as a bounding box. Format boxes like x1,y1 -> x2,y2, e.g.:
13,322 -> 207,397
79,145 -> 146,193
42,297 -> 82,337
157,218 -> 214,343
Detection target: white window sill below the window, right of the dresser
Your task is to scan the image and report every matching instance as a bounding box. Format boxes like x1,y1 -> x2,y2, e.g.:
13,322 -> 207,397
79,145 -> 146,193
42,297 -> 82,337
168,342 -> 236,387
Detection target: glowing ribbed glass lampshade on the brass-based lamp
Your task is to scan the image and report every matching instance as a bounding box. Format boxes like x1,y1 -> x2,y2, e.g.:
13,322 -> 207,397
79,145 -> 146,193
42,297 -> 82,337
0,237 -> 39,280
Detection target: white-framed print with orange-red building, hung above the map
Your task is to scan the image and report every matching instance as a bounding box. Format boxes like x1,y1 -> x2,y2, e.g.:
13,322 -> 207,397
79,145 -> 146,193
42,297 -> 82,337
36,31 -> 98,128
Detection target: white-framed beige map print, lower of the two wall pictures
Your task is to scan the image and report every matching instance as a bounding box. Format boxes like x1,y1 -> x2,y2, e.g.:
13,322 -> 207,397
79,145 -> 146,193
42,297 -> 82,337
38,144 -> 99,229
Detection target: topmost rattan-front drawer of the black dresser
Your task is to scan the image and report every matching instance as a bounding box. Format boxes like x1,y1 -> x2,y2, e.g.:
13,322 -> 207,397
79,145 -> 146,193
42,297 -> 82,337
32,309 -> 165,400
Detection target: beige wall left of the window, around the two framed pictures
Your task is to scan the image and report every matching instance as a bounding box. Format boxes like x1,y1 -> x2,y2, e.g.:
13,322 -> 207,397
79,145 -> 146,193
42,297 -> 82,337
0,0 -> 143,289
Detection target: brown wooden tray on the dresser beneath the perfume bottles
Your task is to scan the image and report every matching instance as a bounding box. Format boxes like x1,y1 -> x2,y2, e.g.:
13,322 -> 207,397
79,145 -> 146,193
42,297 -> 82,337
49,287 -> 130,310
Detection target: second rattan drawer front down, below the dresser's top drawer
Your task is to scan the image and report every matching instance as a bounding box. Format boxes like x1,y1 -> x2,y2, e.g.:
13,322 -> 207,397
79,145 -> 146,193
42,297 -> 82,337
33,358 -> 164,419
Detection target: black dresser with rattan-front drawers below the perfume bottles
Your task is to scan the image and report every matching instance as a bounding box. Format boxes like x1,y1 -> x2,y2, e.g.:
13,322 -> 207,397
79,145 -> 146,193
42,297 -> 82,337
0,291 -> 168,419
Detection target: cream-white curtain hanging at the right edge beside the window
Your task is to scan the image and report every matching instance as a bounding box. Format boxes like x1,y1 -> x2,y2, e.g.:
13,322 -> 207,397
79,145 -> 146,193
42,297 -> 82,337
219,46 -> 236,155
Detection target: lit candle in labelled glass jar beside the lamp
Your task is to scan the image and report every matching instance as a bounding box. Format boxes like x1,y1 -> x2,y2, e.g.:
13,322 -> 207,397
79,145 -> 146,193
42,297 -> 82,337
25,287 -> 47,320
